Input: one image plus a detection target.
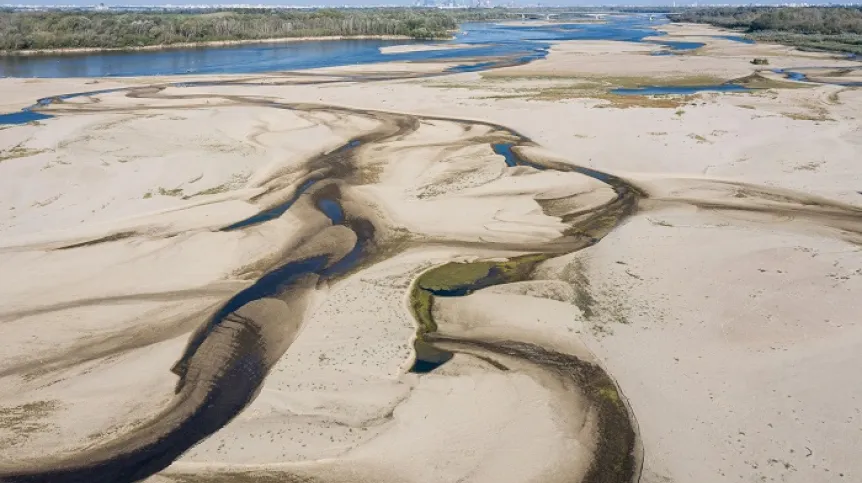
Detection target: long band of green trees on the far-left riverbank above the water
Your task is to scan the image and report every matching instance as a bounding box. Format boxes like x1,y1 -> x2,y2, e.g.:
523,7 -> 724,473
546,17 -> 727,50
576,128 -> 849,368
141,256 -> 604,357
0,8 -> 506,51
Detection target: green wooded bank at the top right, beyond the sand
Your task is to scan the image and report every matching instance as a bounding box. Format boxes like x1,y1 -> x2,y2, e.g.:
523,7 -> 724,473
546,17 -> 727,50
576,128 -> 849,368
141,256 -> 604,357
676,7 -> 862,54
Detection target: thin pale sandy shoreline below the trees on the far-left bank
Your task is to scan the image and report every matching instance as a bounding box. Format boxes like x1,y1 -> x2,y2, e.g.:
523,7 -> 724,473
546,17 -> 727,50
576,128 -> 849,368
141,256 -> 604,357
0,35 -> 451,57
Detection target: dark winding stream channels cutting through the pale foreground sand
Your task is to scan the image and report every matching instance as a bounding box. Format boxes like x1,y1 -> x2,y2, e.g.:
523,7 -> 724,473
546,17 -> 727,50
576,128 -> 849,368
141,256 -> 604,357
0,78 -> 640,483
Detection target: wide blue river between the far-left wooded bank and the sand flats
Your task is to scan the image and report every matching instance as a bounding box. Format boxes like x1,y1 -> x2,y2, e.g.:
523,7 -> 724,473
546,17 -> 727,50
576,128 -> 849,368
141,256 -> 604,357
0,16 -> 676,77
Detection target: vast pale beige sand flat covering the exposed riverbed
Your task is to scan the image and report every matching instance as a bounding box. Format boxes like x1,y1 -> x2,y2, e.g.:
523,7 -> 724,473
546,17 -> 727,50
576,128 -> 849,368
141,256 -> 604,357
0,21 -> 862,483
